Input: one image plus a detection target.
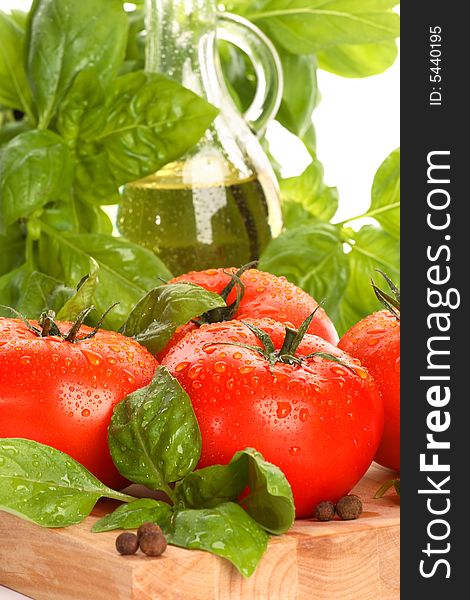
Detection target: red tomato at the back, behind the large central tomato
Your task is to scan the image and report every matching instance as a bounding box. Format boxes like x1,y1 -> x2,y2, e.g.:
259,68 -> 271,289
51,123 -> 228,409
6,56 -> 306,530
161,268 -> 339,359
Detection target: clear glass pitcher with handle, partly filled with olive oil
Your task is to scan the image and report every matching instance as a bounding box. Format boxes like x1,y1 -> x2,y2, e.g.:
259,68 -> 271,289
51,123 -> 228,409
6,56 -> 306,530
117,0 -> 282,275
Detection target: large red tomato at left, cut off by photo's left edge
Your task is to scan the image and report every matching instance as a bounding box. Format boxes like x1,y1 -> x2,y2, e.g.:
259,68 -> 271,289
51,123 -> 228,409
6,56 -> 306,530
0,317 -> 157,488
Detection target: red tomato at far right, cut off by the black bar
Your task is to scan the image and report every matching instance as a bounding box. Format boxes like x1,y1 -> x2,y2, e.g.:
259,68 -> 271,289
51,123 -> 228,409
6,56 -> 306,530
338,310 -> 400,471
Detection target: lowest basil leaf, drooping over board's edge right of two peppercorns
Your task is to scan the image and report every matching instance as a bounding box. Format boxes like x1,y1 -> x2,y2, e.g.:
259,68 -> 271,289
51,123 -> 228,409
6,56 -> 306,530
164,502 -> 269,577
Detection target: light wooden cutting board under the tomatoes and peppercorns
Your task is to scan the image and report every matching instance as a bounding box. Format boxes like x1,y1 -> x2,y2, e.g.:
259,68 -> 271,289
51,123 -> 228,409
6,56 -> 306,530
0,464 -> 399,600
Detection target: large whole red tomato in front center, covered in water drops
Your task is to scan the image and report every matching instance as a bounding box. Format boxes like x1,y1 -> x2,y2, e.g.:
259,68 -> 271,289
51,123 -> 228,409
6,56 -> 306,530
163,319 -> 383,518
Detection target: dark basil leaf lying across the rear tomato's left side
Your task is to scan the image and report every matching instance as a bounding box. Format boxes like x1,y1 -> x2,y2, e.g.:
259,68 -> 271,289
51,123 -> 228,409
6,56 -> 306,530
121,283 -> 225,354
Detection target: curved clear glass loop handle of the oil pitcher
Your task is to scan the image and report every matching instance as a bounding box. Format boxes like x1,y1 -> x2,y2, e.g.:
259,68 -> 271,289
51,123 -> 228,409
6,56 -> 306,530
217,12 -> 284,136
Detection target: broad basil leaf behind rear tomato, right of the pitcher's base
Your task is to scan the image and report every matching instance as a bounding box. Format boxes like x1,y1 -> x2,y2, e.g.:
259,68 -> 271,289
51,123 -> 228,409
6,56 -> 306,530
259,222 -> 348,319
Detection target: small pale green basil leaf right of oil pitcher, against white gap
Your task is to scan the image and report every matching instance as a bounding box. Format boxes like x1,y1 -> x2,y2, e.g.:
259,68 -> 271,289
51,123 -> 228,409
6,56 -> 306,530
280,157 -> 339,224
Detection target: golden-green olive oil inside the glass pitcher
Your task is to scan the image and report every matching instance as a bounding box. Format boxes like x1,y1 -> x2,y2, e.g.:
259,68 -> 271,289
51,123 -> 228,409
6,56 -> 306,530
117,174 -> 271,275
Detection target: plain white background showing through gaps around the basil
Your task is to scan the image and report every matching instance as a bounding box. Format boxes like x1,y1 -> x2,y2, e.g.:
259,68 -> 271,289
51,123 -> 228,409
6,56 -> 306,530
0,0 -> 400,600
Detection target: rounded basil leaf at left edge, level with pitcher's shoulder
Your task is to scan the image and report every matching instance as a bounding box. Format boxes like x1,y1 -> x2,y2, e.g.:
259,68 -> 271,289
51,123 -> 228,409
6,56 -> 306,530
0,130 -> 72,233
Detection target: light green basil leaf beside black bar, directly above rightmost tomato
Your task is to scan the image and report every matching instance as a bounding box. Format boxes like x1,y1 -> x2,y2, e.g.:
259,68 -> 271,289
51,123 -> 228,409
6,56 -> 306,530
330,225 -> 400,336
